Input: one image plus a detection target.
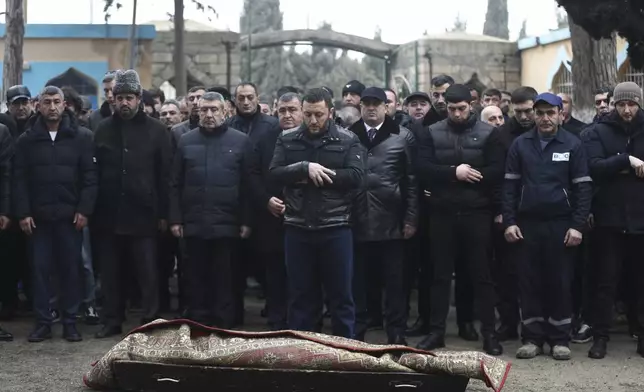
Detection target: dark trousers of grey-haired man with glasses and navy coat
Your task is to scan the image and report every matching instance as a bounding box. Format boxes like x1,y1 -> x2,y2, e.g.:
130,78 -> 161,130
186,237 -> 237,328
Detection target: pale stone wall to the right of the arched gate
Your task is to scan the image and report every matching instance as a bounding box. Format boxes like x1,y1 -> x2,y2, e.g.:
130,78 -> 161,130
392,34 -> 521,92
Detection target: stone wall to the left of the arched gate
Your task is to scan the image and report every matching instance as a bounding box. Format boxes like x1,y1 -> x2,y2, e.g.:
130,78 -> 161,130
152,31 -> 241,87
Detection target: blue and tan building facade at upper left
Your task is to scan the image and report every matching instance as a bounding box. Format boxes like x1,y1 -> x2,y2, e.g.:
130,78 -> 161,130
0,24 -> 156,108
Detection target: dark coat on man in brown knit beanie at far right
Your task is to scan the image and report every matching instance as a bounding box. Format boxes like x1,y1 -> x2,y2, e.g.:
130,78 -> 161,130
584,109 -> 644,234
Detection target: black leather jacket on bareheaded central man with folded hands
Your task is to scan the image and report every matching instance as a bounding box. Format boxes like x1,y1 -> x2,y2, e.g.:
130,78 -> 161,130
270,122 -> 366,230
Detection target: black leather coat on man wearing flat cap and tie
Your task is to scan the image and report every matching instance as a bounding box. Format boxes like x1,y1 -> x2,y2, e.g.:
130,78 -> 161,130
349,117 -> 418,242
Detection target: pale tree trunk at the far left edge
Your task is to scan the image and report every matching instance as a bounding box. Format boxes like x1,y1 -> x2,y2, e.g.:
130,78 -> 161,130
2,0 -> 25,100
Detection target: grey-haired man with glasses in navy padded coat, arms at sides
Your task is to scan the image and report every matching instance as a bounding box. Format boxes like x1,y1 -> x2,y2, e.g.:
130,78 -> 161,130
170,92 -> 252,328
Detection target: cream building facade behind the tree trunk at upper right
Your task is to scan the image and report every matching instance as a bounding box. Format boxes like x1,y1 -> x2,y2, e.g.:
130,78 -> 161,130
517,28 -> 632,94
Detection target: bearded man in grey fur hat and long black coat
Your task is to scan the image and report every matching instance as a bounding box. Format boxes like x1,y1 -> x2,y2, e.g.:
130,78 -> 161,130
92,69 -> 172,339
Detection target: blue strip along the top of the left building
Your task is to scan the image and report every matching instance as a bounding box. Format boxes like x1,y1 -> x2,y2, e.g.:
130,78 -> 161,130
0,24 -> 156,40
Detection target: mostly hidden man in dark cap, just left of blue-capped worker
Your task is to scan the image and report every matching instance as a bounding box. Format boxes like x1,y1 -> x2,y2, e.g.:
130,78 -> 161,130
492,86 -> 538,342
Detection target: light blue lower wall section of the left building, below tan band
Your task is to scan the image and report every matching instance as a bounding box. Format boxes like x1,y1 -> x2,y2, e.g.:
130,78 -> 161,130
0,61 -> 109,109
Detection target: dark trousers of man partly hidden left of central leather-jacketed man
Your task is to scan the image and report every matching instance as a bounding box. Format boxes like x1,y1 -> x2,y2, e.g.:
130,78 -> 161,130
261,251 -> 288,330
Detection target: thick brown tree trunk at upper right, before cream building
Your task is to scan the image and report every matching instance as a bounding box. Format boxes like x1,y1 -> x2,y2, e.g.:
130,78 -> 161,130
568,18 -> 617,122
